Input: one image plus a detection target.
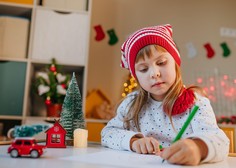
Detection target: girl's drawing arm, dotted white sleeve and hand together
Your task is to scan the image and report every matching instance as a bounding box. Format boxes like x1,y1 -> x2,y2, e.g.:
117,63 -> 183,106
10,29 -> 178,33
161,95 -> 229,165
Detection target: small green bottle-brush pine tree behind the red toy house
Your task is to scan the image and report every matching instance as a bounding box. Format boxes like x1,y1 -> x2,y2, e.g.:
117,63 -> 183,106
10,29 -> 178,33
60,72 -> 85,139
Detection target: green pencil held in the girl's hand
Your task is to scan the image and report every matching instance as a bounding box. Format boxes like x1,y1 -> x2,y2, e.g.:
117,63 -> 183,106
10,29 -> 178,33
162,106 -> 199,163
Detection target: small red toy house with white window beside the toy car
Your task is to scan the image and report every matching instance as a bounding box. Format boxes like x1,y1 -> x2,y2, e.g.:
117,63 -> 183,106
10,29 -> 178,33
45,120 -> 66,148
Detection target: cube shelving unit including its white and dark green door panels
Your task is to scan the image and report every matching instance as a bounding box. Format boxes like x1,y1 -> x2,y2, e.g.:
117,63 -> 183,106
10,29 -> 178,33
0,0 -> 92,135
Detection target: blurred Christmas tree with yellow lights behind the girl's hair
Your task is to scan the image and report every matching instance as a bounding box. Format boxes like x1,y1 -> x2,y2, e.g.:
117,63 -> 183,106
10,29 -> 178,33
121,74 -> 138,97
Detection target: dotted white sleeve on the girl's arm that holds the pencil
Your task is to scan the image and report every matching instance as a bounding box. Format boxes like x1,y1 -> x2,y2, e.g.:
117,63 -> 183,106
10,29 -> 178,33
188,95 -> 229,162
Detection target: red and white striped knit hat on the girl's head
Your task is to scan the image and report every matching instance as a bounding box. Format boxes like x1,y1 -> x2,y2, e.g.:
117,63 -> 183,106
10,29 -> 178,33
121,24 -> 181,78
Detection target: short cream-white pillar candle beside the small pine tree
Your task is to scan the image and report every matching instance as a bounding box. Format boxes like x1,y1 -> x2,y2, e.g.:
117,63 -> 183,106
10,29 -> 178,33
74,128 -> 88,148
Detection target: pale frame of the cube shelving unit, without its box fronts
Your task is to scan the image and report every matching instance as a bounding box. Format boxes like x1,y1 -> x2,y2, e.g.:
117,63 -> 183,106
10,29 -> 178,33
0,0 -> 92,135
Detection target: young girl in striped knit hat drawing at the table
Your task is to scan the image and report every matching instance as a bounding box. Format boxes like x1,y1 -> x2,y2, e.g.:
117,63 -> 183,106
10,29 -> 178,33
102,25 -> 229,165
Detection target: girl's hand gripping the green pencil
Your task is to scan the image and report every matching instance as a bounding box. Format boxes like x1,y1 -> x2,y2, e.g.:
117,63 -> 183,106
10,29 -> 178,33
160,139 -> 208,165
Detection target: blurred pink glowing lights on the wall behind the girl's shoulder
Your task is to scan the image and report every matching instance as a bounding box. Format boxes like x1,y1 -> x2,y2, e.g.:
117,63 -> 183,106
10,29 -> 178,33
195,70 -> 236,116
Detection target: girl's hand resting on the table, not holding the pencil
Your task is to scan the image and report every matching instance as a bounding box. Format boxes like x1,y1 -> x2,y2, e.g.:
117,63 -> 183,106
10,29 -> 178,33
130,137 -> 160,155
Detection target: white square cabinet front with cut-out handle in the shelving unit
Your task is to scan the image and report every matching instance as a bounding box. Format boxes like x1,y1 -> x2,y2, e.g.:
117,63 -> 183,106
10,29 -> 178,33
32,9 -> 89,66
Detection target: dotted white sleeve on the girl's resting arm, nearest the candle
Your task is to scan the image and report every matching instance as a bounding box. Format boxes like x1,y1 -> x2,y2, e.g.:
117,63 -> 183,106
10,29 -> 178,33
101,94 -> 143,150
